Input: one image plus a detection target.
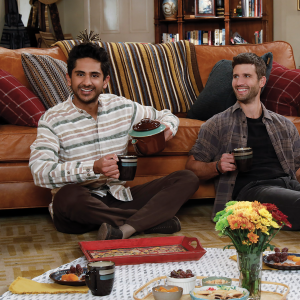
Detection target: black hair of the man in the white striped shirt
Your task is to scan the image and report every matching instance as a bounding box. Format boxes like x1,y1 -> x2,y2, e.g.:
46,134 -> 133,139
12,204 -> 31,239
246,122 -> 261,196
68,43 -> 110,78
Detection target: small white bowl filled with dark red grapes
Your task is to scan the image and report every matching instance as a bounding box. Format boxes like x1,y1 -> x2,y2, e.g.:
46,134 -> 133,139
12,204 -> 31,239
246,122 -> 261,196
167,269 -> 196,294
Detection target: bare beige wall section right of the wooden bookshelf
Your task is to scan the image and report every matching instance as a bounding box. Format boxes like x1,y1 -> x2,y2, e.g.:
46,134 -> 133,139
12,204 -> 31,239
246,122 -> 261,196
274,0 -> 300,69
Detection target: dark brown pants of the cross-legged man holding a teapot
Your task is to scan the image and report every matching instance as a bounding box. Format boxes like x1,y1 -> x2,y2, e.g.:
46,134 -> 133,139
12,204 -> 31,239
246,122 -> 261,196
53,170 -> 199,233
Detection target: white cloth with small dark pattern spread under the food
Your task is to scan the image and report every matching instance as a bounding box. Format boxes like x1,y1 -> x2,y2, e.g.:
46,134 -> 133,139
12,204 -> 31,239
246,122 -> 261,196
0,248 -> 300,300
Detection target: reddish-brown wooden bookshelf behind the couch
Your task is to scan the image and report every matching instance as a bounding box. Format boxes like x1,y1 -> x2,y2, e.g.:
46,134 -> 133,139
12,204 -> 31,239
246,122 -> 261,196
154,0 -> 273,45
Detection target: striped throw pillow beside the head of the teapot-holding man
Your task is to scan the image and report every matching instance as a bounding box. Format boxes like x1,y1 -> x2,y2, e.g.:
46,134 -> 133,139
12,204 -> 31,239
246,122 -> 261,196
21,53 -> 72,109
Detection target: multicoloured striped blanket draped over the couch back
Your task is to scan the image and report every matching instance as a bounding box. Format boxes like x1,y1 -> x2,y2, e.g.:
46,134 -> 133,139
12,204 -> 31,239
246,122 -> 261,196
55,40 -> 202,114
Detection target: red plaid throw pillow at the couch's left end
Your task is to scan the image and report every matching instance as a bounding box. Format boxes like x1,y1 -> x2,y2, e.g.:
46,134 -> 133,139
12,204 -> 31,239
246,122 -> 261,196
0,69 -> 46,127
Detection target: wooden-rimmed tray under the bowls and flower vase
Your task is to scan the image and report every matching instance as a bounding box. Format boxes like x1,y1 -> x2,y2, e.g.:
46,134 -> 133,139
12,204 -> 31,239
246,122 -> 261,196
133,276 -> 290,300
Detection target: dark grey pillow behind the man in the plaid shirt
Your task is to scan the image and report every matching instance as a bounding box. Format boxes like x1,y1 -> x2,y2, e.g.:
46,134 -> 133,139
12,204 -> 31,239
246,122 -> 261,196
187,52 -> 273,120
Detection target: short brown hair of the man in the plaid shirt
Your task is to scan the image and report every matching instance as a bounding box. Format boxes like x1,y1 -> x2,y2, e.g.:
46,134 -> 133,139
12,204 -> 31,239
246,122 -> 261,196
232,52 -> 267,79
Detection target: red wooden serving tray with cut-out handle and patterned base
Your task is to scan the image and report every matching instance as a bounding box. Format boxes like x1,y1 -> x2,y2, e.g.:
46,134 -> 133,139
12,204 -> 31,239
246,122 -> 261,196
79,236 -> 206,266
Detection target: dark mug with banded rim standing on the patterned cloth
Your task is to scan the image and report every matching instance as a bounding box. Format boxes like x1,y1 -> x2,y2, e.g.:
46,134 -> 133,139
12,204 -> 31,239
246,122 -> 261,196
85,261 -> 115,296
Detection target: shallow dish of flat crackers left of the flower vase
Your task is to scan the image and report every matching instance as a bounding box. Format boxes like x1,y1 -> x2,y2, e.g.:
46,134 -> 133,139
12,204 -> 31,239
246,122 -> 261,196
190,285 -> 249,300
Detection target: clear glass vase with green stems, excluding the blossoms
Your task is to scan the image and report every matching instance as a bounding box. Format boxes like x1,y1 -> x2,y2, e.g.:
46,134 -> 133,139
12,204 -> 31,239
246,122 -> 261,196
237,252 -> 263,300
